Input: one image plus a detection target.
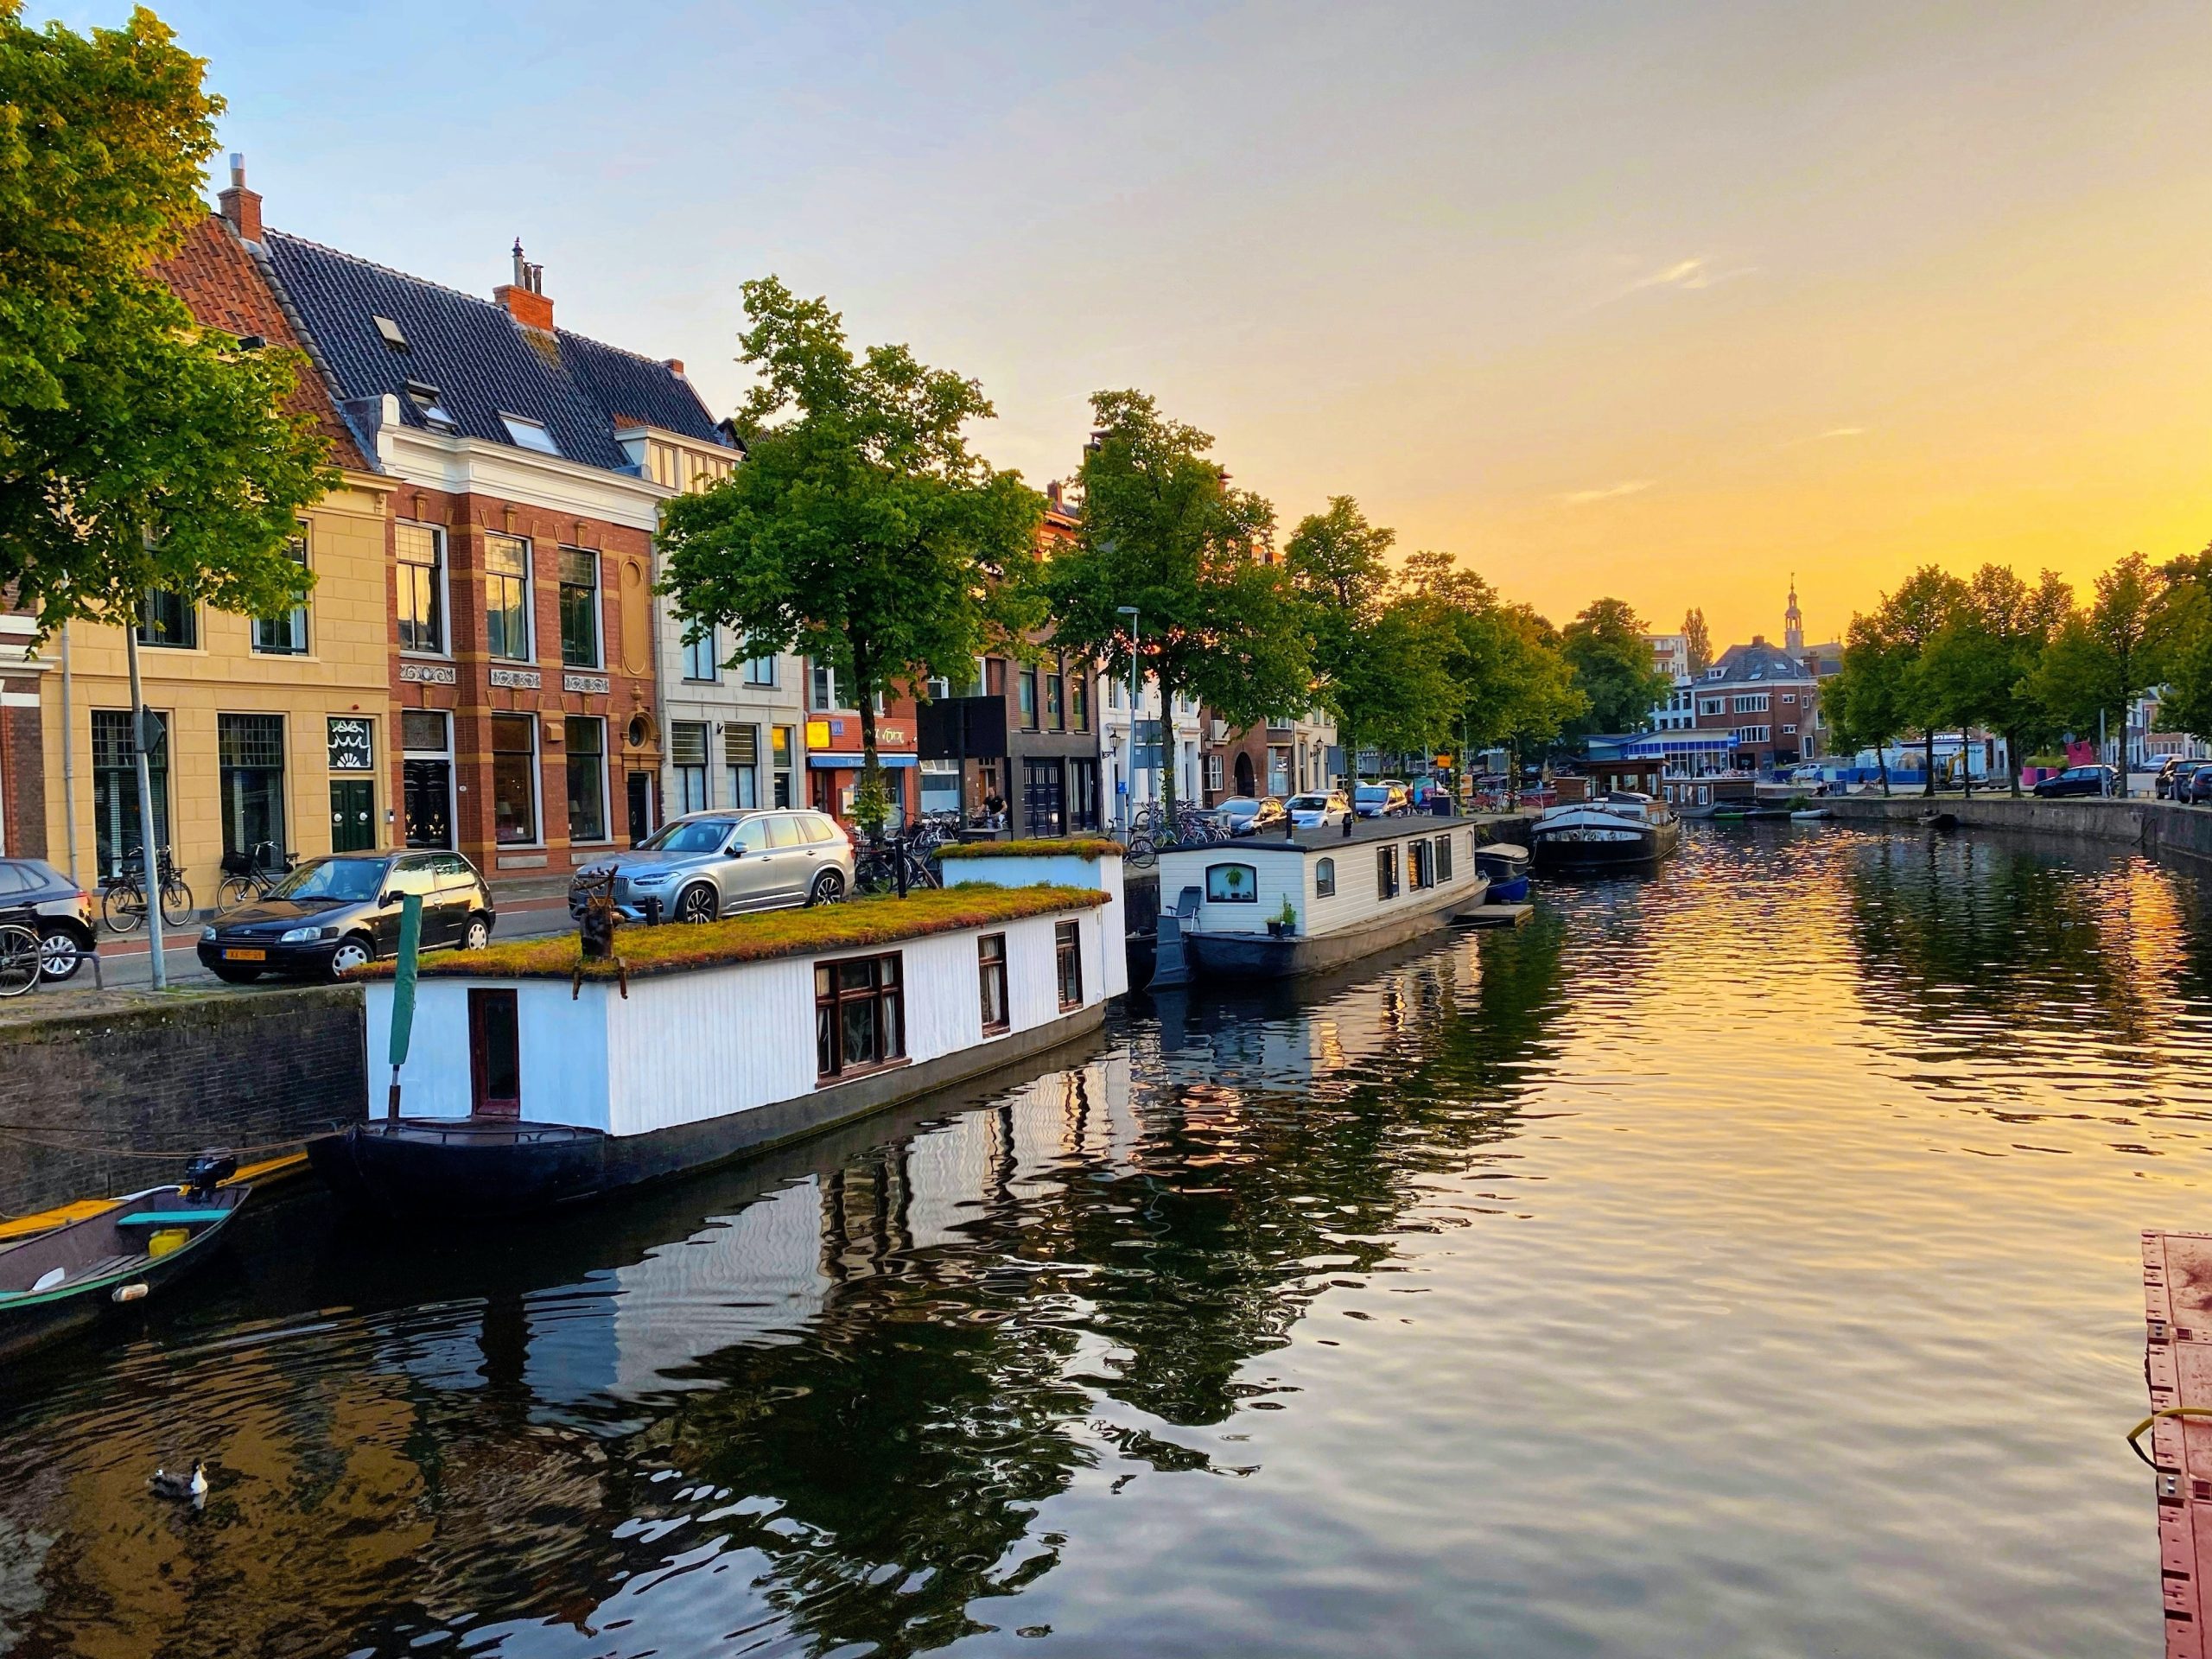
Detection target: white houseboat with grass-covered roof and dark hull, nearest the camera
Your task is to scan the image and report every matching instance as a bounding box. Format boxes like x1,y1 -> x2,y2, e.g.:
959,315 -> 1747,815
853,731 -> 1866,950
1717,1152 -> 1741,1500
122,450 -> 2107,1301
309,842 -> 1126,1219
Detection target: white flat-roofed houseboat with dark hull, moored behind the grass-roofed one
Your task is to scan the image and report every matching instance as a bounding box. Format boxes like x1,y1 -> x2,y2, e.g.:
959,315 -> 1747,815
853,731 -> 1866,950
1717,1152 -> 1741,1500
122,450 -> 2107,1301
1153,814 -> 1489,984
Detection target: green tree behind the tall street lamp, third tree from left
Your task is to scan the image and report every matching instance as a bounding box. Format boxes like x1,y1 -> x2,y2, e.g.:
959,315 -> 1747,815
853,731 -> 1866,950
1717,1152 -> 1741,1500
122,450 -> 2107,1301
1044,391 -> 1314,827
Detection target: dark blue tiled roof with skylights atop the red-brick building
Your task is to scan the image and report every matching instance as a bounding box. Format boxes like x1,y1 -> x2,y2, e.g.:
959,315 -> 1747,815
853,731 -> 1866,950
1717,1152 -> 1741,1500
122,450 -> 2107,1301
264,230 -> 719,471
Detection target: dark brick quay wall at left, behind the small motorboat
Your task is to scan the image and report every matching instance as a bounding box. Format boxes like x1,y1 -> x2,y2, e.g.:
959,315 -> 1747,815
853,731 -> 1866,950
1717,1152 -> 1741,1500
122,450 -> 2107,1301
0,987 -> 367,1214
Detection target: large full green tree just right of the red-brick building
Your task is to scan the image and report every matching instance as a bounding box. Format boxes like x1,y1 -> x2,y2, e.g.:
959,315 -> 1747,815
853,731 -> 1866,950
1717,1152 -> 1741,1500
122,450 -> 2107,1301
657,276 -> 1044,834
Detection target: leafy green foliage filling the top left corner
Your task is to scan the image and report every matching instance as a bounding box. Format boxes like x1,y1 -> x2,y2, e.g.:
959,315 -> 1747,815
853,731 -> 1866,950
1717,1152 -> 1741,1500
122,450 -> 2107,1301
0,0 -> 336,628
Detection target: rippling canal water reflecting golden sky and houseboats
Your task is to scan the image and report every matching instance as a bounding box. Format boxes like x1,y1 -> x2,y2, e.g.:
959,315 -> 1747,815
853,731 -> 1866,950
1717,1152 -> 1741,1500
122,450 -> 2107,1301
0,825 -> 2212,1659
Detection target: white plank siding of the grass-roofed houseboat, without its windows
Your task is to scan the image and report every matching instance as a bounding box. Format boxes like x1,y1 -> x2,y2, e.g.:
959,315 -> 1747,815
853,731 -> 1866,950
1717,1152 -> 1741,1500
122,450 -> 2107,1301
367,907 -> 1122,1137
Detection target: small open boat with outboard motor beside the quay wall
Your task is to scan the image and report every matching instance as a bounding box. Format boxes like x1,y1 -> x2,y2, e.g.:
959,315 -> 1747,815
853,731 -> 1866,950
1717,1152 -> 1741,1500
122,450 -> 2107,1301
0,1154 -> 252,1360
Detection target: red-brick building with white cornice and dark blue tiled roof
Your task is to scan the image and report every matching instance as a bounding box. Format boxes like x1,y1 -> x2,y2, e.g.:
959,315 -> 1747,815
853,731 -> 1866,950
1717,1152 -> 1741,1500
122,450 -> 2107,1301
264,203 -> 736,874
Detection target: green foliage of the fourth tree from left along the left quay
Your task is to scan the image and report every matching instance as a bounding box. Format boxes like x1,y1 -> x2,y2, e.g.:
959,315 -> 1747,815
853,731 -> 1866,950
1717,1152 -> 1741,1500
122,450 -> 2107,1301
1283,495 -> 1458,757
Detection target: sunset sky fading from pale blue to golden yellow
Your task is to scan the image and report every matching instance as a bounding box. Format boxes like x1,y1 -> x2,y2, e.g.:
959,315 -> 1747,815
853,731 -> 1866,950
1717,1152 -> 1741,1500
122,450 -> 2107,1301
69,0 -> 2212,644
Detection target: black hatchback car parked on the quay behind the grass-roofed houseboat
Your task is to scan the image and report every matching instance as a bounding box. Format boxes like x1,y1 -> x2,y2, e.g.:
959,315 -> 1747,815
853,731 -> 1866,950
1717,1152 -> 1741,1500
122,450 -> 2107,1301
199,852 -> 498,984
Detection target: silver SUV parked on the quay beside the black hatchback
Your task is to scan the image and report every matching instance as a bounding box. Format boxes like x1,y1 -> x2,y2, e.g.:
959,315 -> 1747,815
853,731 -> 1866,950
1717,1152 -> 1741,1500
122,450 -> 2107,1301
569,807 -> 852,923
